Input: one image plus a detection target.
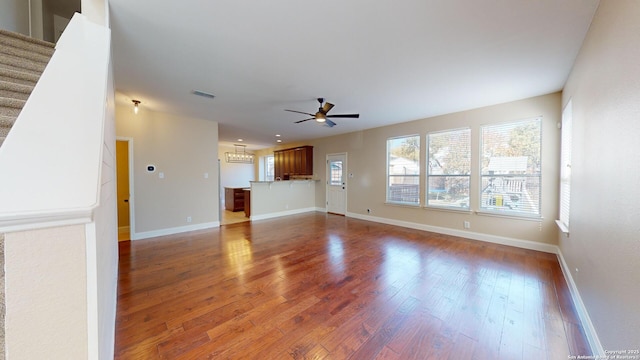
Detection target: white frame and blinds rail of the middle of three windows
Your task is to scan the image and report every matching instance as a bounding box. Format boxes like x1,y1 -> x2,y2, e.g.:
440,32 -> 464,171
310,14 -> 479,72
424,127 -> 473,211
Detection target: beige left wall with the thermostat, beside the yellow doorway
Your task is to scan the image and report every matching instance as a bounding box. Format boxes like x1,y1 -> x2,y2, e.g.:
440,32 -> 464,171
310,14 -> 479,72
116,104 -> 219,239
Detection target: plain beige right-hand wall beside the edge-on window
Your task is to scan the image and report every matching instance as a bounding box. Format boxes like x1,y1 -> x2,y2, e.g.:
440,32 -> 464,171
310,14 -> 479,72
560,0 -> 640,350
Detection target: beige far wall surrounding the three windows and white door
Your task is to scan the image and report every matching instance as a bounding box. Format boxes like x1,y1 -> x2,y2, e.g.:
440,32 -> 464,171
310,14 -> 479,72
283,93 -> 561,244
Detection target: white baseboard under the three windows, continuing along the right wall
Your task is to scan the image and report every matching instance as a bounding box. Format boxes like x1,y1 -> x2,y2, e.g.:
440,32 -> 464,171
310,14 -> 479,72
347,213 -> 605,356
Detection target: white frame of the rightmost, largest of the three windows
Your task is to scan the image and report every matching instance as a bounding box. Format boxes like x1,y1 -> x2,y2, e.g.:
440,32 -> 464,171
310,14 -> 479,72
477,116 -> 543,219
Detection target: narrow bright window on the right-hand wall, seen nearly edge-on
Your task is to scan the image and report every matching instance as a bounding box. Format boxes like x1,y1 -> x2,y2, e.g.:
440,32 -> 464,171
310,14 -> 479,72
558,100 -> 573,233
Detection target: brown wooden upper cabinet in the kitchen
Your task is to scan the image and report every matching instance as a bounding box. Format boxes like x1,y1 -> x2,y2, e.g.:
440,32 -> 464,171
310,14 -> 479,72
273,145 -> 313,180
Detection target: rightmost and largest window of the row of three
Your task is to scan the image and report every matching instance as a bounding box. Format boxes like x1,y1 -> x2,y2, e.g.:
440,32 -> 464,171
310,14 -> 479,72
480,118 -> 542,216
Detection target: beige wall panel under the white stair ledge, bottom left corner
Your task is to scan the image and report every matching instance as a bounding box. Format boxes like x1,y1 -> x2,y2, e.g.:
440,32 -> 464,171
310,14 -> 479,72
5,225 -> 88,359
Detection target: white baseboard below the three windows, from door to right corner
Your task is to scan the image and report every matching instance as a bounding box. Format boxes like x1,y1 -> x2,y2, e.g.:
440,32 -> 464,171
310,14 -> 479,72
347,213 -> 558,254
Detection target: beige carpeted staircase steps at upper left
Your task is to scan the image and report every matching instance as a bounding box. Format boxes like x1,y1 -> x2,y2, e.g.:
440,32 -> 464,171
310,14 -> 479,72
0,29 -> 55,146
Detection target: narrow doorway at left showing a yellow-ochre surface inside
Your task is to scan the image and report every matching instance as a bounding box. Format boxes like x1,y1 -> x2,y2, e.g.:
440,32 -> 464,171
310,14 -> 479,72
116,139 -> 132,241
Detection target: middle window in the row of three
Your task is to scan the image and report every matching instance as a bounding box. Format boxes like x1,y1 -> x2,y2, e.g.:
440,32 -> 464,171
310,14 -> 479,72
426,129 -> 471,209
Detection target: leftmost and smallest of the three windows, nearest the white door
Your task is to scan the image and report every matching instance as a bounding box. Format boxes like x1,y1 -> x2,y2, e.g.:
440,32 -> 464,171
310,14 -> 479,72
387,135 -> 420,205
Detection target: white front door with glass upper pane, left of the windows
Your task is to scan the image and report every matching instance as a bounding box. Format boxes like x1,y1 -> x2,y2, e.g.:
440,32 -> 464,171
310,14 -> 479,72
327,154 -> 347,215
